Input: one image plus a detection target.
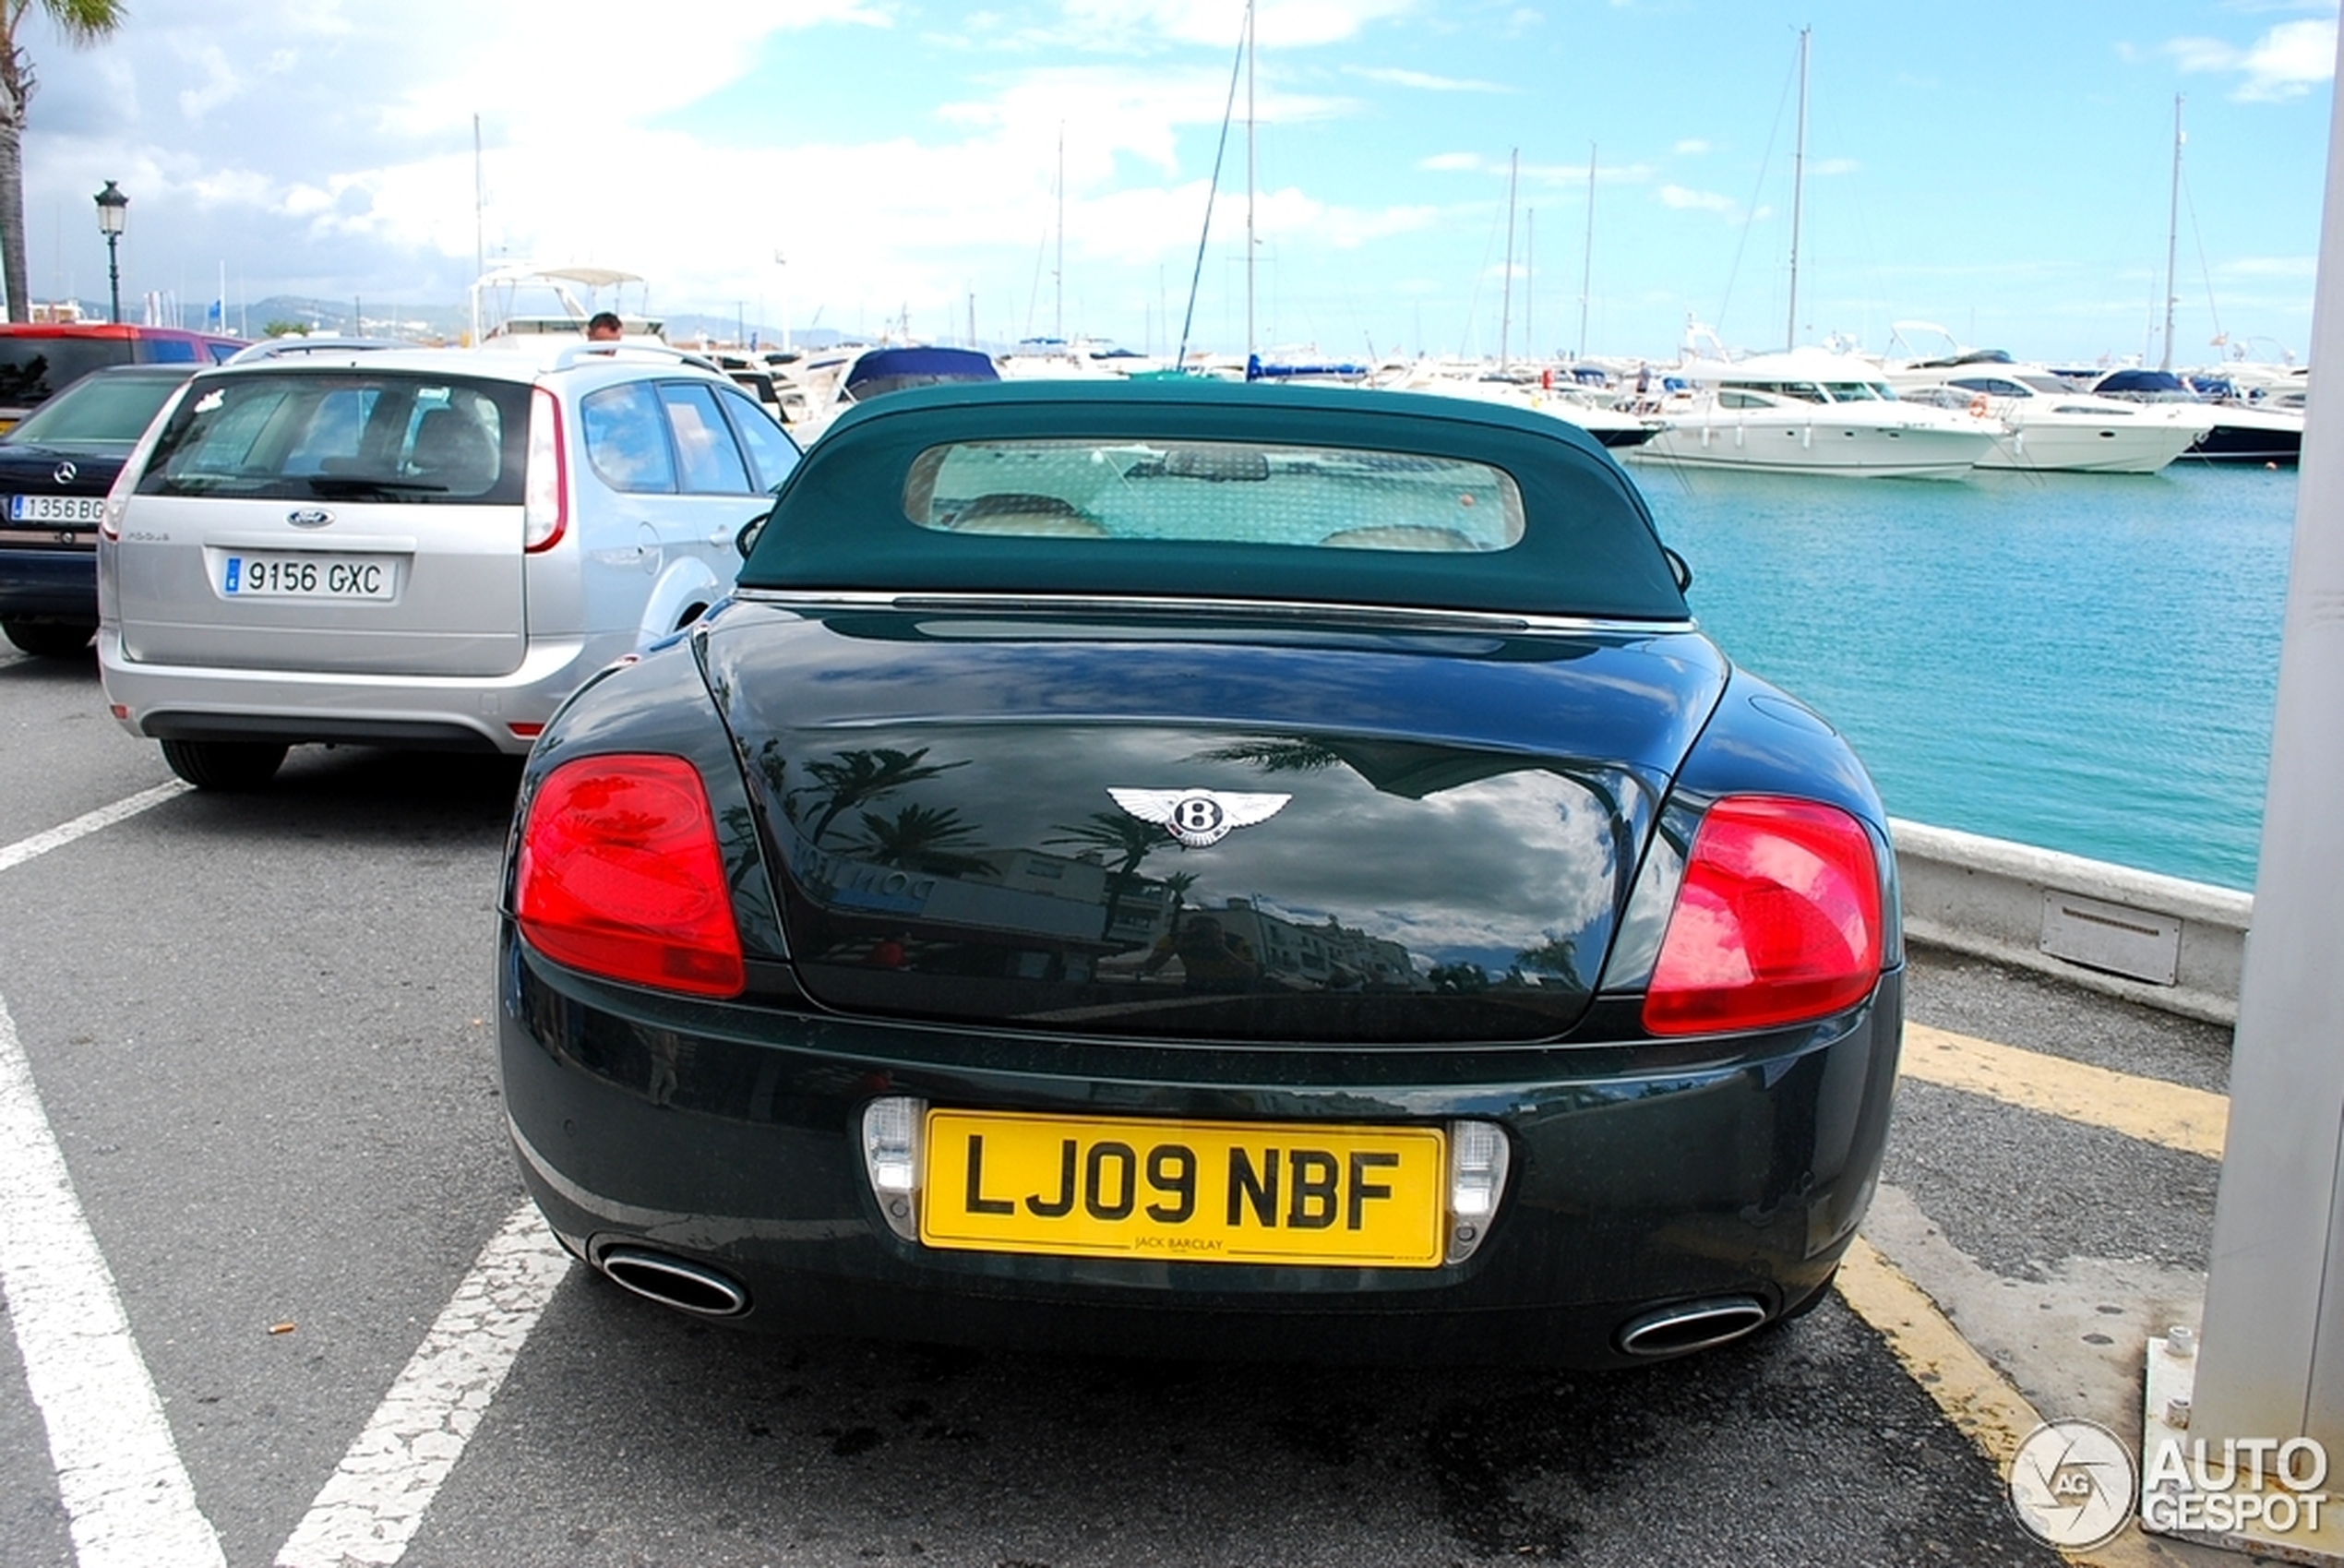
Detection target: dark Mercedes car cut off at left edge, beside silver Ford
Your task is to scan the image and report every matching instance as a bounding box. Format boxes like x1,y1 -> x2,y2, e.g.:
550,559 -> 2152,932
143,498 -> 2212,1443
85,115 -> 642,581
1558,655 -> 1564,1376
0,364 -> 199,659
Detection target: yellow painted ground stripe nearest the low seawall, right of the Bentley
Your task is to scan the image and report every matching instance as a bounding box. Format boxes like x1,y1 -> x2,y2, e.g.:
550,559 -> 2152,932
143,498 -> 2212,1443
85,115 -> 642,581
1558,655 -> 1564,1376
1901,1024 -> 2230,1160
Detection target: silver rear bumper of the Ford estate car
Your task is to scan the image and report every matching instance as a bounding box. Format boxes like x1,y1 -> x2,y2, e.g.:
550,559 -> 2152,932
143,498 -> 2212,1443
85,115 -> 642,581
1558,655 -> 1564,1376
99,624 -> 633,755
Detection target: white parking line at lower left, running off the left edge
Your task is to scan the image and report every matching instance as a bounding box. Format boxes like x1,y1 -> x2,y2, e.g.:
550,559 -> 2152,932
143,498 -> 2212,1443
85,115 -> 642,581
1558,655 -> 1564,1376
0,988 -> 227,1568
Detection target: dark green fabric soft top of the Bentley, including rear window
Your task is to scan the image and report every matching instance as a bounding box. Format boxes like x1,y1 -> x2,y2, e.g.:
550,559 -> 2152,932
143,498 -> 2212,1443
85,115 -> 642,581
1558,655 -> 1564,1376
741,379 -> 1688,621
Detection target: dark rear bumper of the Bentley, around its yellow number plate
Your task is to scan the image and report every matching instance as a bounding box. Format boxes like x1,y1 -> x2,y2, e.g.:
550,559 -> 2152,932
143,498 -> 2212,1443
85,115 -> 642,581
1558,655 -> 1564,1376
499,926 -> 1903,1367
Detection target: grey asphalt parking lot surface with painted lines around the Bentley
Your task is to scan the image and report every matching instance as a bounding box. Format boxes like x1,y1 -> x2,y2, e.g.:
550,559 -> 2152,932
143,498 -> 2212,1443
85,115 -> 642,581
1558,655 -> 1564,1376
0,637 -> 2245,1568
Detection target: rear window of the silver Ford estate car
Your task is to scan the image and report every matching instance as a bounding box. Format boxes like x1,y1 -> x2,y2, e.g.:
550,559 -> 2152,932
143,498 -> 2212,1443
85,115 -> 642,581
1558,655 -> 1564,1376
138,370 -> 530,507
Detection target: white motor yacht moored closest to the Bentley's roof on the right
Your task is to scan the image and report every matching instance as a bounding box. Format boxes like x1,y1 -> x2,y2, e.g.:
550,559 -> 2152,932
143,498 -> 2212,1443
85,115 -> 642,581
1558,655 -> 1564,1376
1627,349 -> 2006,478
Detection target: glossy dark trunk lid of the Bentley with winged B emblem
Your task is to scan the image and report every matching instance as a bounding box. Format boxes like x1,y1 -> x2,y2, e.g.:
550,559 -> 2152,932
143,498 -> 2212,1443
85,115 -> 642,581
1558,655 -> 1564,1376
706,604 -> 1725,1043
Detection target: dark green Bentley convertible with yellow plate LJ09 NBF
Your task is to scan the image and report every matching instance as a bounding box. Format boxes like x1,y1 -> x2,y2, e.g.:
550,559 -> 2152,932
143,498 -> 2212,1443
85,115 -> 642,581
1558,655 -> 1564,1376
499,382 -> 1903,1364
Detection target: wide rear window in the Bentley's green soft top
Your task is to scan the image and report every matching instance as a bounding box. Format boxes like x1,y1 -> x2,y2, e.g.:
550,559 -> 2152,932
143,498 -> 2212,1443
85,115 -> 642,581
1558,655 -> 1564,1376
904,440 -> 1521,553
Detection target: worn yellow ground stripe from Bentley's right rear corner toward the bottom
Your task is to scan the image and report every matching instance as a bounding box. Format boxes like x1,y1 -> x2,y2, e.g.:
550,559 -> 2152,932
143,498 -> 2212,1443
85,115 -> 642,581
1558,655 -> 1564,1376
1837,1235 -> 2180,1568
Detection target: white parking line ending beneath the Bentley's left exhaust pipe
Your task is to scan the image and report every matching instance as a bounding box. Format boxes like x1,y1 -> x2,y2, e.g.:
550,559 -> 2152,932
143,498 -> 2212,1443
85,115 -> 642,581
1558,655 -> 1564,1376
277,1203 -> 569,1568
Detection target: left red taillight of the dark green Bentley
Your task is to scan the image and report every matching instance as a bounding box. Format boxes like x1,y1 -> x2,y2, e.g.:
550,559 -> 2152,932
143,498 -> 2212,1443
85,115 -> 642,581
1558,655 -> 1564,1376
513,755 -> 747,996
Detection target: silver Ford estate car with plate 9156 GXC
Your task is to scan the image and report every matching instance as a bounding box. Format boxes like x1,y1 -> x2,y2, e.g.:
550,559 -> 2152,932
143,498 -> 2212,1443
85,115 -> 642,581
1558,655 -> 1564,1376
99,342 -> 797,790
